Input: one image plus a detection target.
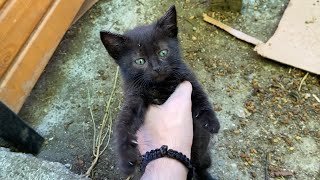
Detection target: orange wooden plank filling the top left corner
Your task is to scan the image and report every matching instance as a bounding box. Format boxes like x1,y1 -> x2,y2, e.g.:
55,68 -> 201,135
0,0 -> 52,77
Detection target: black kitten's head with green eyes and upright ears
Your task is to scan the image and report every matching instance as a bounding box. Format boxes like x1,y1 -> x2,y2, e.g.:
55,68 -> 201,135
100,6 -> 181,82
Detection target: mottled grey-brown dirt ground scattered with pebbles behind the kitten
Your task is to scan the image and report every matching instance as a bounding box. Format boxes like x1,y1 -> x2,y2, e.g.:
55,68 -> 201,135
20,0 -> 320,179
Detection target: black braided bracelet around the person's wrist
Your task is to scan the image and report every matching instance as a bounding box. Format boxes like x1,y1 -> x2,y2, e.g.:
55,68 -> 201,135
140,145 -> 194,180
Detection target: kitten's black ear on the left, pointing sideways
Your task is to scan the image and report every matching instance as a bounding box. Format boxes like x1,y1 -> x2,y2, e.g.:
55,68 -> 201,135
100,31 -> 127,60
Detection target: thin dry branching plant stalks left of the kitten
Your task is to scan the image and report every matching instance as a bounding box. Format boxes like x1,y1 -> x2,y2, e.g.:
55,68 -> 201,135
85,67 -> 119,177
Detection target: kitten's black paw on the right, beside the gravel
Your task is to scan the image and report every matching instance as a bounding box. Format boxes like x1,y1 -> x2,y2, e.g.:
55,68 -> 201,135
195,111 -> 220,133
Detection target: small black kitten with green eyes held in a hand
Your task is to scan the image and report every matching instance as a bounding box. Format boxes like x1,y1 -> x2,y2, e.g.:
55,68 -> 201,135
100,6 -> 220,179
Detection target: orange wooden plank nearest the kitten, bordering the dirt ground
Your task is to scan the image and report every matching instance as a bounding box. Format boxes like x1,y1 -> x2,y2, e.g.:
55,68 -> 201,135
0,0 -> 84,112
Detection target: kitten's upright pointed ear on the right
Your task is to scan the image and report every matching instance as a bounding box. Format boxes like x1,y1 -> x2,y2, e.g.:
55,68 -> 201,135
156,5 -> 178,37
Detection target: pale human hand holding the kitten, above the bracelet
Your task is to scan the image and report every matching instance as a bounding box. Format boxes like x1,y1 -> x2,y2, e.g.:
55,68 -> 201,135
137,81 -> 193,158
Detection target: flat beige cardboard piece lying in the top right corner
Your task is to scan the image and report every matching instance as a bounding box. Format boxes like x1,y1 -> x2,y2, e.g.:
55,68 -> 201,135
255,0 -> 320,74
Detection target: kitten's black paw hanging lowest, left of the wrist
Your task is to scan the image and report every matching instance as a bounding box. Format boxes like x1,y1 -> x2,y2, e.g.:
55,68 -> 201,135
119,134 -> 140,175
